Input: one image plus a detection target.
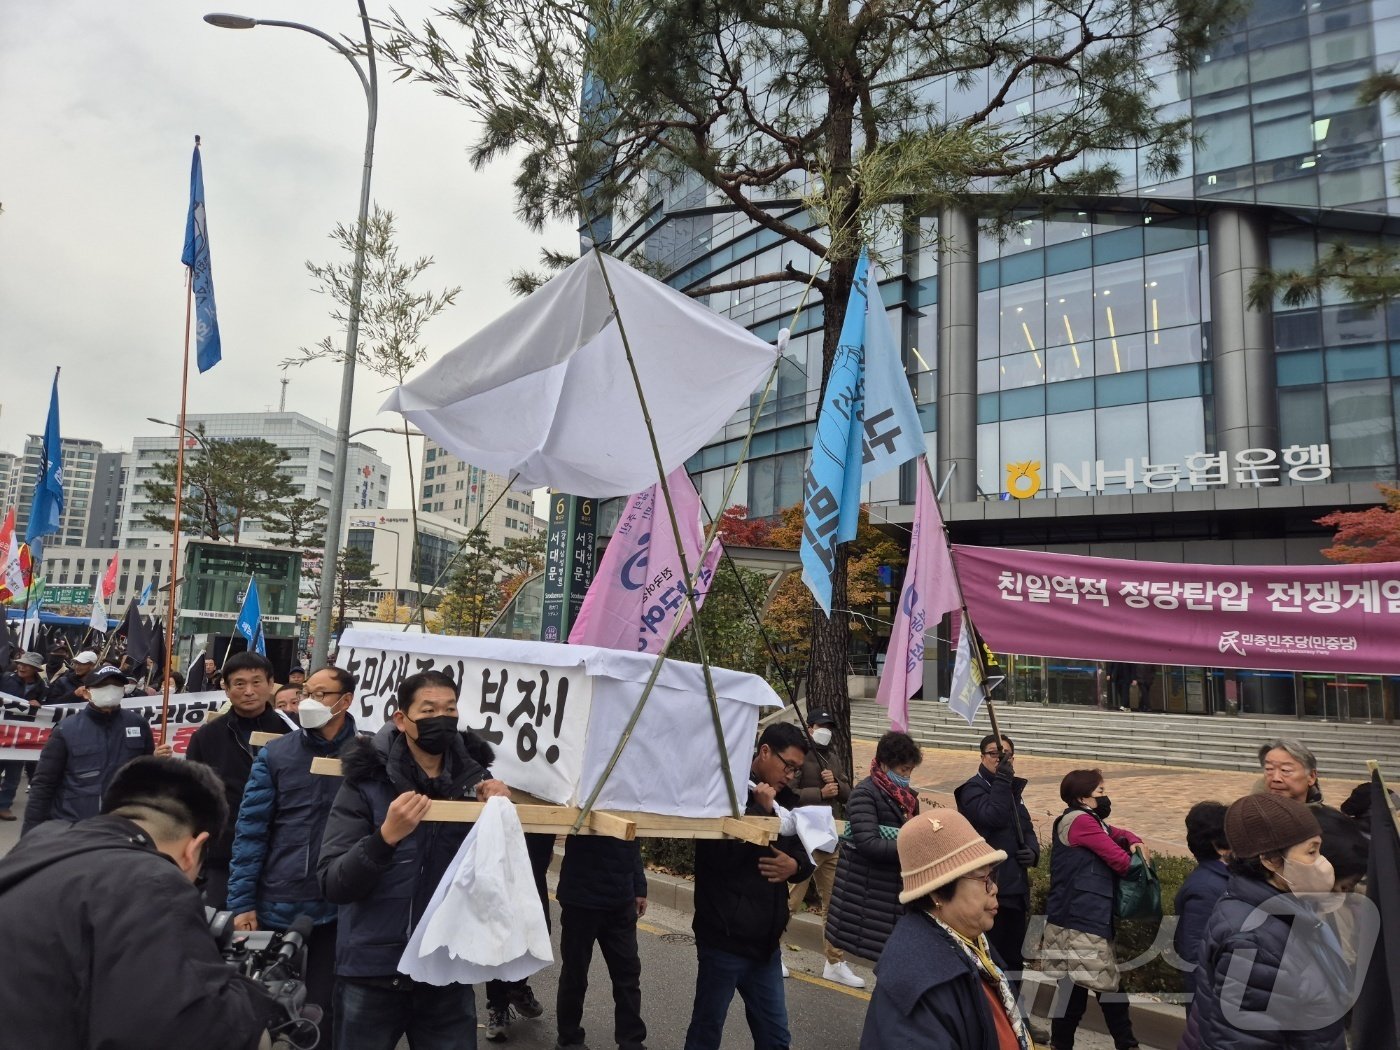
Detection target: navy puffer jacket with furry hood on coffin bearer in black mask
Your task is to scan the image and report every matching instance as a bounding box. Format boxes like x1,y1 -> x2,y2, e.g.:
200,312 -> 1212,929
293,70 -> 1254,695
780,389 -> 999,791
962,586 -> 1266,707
316,725 -> 494,979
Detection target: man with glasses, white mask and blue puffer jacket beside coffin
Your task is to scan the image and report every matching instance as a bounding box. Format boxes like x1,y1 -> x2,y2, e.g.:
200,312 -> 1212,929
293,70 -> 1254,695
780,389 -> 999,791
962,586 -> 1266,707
228,666 -> 356,1046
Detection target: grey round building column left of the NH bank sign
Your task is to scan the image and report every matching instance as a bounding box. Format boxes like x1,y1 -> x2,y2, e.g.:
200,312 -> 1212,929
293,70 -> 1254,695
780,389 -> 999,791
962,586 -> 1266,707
938,207 -> 977,503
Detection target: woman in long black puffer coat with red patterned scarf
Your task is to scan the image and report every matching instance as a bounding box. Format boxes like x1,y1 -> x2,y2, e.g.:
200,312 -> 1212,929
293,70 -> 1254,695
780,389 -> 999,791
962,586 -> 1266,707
826,732 -> 924,960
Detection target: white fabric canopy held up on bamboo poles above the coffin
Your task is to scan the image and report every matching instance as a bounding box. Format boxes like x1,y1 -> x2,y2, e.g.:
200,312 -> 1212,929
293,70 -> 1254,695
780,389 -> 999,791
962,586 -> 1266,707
382,252 -> 777,498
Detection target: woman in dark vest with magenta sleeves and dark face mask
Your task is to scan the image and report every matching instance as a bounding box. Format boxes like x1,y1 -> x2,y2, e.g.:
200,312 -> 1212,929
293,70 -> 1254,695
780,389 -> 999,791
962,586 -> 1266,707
1042,769 -> 1152,1050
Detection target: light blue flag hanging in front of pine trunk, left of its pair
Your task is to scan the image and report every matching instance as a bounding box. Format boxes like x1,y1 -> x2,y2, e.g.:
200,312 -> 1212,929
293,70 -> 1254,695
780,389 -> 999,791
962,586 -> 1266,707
801,251 -> 869,616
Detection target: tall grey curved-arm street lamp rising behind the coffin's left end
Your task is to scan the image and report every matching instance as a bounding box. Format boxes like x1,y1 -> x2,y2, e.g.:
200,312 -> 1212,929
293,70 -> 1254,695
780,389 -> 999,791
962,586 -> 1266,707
204,0 -> 379,666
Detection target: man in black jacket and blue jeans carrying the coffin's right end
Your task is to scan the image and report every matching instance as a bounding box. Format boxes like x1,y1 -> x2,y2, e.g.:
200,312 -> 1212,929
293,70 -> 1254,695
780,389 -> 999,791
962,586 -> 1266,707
685,722 -> 812,1050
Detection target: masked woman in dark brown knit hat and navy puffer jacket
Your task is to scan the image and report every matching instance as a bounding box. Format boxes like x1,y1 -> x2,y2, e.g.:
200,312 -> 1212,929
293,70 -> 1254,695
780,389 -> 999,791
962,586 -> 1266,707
1191,794 -> 1355,1050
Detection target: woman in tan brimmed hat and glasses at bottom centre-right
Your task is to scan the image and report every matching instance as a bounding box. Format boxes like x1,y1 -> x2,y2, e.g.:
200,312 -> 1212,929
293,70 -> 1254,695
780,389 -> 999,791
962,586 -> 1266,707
861,809 -> 1035,1050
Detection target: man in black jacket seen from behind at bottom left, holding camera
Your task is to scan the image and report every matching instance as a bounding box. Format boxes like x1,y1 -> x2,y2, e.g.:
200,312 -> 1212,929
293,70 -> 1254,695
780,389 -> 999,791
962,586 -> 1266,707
0,757 -> 279,1050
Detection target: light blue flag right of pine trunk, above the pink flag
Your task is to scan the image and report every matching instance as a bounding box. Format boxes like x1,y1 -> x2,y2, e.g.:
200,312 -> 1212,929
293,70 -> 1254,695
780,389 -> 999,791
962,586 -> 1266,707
847,264 -> 925,484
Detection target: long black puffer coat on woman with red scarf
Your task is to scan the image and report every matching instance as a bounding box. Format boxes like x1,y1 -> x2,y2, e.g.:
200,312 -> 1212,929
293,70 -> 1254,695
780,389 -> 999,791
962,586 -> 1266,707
826,778 -> 907,959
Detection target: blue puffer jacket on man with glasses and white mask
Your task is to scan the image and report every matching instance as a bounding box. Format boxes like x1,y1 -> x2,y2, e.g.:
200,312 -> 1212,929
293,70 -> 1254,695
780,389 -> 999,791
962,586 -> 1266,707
228,715 -> 356,930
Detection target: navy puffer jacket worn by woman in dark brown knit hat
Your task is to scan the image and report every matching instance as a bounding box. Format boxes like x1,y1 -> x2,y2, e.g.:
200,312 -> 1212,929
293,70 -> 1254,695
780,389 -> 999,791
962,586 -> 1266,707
1191,875 -> 1354,1050
